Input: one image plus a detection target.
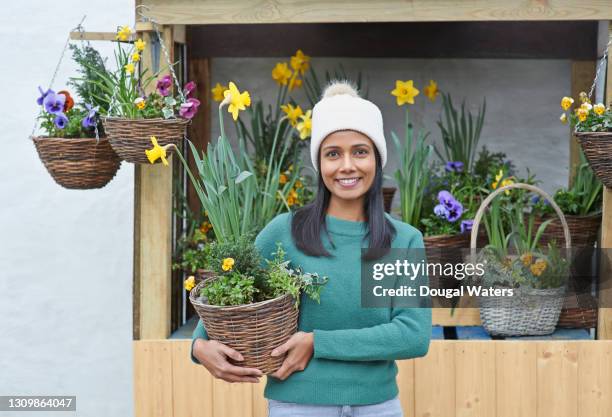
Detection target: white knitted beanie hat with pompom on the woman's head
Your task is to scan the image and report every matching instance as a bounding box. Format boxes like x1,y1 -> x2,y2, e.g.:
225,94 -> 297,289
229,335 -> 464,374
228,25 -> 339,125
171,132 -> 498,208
310,81 -> 387,170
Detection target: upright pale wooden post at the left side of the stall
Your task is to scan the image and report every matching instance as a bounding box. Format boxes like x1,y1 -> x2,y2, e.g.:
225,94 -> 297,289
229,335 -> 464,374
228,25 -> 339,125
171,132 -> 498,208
133,27 -> 174,339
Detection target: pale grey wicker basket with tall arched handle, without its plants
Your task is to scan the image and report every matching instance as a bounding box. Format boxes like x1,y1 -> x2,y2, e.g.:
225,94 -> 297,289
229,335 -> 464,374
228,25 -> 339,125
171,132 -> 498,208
470,183 -> 571,336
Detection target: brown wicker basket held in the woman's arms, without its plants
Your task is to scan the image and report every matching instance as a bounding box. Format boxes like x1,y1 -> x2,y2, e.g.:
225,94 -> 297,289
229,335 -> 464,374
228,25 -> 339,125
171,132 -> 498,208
189,277 -> 298,374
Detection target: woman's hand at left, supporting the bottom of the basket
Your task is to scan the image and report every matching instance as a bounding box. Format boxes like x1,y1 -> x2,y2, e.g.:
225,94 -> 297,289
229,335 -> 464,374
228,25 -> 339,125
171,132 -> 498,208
193,339 -> 263,383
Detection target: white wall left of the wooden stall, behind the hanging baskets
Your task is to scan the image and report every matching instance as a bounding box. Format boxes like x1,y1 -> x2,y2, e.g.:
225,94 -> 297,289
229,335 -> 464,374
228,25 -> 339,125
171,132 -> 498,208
0,0 -> 134,417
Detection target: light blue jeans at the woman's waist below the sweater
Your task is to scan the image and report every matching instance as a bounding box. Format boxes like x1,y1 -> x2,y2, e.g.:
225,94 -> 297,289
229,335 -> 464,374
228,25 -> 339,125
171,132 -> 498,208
268,396 -> 404,417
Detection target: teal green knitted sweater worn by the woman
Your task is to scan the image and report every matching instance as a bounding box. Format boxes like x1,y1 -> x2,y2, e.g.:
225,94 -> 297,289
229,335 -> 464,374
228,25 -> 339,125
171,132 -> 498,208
191,213 -> 431,405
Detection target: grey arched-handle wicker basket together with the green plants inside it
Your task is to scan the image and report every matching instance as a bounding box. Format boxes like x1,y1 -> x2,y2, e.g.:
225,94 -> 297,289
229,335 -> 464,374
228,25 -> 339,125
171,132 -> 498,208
470,183 -> 571,336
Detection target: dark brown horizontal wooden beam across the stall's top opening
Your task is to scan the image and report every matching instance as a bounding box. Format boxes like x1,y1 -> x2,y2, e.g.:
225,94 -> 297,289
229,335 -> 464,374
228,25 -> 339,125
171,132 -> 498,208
187,22 -> 598,61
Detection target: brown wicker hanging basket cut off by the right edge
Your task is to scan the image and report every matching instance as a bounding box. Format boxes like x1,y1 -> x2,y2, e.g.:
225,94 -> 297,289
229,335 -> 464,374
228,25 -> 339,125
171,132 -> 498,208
574,132 -> 612,188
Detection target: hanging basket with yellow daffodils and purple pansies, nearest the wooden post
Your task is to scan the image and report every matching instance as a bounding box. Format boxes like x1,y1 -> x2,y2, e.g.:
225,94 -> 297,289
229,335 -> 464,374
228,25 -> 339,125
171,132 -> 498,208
80,26 -> 200,163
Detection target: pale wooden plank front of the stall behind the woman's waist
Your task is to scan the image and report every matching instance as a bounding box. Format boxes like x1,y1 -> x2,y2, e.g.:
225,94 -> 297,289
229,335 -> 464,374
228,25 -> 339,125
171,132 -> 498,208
133,340 -> 612,417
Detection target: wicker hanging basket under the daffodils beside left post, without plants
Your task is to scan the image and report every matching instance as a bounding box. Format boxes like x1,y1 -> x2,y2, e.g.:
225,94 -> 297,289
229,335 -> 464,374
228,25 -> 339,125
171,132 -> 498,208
102,117 -> 189,164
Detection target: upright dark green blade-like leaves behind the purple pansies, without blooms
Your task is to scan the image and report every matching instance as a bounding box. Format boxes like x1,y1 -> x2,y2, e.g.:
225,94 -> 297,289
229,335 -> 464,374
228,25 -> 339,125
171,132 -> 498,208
435,93 -> 487,172
